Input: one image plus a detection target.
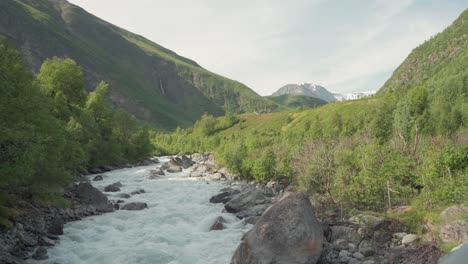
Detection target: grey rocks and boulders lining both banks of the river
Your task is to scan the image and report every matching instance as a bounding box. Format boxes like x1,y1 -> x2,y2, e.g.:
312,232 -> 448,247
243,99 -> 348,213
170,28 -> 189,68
0,154 -> 468,264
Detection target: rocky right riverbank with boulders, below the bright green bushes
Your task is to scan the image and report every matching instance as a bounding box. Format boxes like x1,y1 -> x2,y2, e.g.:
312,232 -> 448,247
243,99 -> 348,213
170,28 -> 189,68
192,154 -> 468,264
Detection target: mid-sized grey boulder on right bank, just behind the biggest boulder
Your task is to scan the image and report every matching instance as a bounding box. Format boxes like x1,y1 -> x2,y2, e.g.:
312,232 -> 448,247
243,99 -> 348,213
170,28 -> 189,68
224,188 -> 266,213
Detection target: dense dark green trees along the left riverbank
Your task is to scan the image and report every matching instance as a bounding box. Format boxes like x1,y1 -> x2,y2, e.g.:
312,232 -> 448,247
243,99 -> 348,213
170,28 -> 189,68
0,38 -> 152,226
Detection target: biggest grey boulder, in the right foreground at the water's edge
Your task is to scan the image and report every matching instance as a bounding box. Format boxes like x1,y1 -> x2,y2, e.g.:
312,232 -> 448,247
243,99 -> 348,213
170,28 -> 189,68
231,193 -> 323,264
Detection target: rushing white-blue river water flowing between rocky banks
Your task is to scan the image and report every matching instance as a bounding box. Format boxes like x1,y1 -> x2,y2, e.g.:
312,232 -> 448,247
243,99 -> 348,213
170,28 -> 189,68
30,158 -> 251,264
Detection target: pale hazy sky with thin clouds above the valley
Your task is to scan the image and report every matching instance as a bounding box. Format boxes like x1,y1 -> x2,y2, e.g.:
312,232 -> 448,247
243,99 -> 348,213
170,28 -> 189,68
67,0 -> 468,95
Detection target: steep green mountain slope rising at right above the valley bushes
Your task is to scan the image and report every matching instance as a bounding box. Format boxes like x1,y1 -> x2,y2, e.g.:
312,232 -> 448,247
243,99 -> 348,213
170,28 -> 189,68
379,10 -> 468,94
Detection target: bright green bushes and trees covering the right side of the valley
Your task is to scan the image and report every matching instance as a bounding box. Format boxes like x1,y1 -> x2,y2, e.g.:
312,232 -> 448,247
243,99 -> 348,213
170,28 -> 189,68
153,11 -> 468,230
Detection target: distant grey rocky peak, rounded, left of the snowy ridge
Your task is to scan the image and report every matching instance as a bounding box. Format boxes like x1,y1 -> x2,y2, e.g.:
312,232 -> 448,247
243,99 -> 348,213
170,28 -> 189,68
271,83 -> 337,103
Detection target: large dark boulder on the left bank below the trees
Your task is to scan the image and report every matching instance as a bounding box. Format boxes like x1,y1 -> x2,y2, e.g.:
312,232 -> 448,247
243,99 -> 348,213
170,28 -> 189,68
70,182 -> 114,212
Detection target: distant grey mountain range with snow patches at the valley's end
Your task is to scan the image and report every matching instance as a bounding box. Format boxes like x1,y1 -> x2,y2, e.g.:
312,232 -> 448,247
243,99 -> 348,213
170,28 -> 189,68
271,83 -> 377,103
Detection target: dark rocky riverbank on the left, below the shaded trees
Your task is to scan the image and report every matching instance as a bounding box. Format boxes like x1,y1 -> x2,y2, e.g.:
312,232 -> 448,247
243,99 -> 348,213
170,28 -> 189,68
0,159 -> 158,264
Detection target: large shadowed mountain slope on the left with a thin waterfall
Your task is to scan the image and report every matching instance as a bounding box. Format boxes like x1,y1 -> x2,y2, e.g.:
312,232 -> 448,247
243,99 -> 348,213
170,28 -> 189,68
0,0 -> 278,128
